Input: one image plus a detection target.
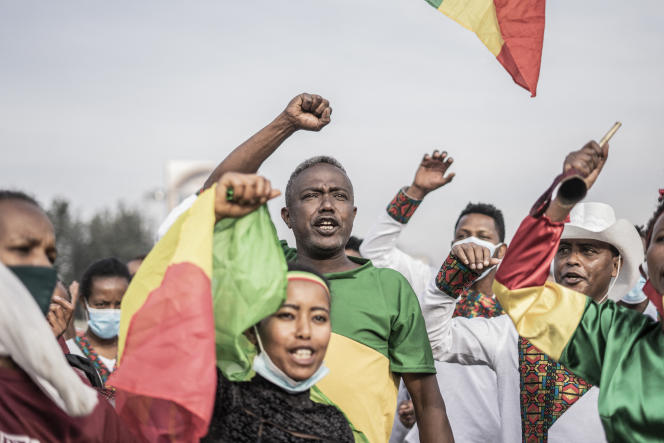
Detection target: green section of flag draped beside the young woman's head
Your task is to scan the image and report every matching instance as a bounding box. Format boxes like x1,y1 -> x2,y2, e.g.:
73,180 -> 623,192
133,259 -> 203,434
212,205 -> 287,381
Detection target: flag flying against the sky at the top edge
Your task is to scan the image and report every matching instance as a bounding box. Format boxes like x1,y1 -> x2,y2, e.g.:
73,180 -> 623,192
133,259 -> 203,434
426,0 -> 544,97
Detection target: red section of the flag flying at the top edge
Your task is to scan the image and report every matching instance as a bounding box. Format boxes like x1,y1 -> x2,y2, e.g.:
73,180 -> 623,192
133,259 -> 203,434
494,0 -> 545,97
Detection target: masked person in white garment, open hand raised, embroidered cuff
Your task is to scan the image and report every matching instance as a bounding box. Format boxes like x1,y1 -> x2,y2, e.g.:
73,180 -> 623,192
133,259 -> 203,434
360,151 -> 506,443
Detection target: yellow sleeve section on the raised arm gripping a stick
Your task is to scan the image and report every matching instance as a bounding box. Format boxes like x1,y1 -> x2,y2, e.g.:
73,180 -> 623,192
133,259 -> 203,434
493,280 -> 588,360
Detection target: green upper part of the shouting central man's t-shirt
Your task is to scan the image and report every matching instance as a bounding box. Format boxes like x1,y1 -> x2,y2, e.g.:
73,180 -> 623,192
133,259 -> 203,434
281,241 -> 436,374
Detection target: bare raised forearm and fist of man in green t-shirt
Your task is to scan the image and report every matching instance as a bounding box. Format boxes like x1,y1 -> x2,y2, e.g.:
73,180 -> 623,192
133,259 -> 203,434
204,93 -> 332,188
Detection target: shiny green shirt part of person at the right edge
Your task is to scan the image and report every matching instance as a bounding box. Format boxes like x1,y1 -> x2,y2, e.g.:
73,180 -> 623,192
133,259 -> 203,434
560,299 -> 664,442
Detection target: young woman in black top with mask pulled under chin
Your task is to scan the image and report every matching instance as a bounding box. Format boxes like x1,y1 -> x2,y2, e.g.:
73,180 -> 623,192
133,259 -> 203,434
203,265 -> 354,442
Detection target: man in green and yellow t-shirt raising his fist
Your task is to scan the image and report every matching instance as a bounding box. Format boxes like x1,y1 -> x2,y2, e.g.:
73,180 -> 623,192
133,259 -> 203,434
200,94 -> 453,442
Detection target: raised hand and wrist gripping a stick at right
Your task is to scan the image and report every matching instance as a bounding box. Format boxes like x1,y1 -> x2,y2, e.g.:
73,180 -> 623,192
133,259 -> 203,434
546,141 -> 609,222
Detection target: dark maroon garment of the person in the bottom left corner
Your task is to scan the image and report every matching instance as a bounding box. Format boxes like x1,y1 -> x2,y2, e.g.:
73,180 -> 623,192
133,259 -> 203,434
0,368 -> 139,443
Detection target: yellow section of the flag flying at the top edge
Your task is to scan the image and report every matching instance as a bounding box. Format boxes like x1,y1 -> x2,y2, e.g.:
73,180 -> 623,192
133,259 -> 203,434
438,0 -> 505,57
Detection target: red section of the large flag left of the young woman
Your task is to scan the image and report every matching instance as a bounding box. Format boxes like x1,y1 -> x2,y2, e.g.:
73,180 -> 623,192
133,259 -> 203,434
108,263 -> 217,442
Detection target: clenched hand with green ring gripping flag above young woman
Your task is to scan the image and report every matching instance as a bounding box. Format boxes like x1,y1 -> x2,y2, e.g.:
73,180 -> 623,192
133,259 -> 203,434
214,172 -> 281,221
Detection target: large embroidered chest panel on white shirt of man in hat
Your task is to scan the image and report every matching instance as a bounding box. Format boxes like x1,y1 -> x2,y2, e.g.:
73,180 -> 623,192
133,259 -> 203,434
519,337 -> 592,443
